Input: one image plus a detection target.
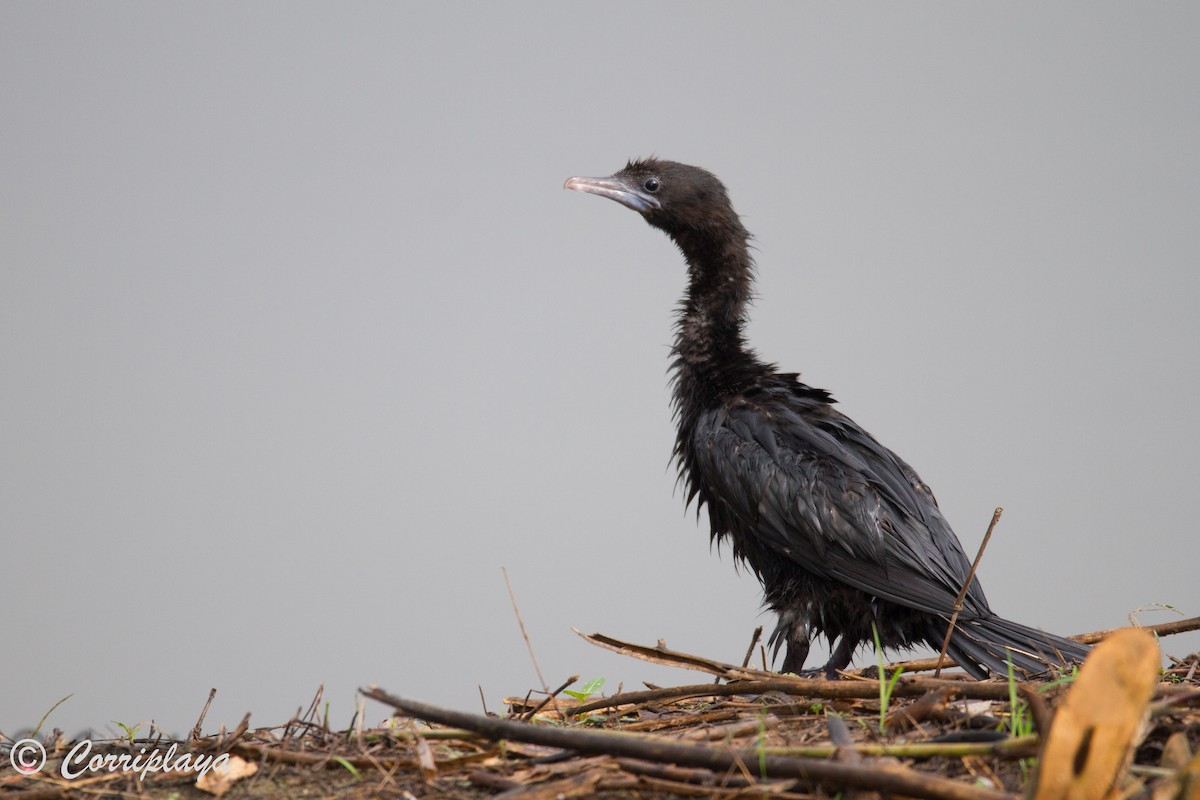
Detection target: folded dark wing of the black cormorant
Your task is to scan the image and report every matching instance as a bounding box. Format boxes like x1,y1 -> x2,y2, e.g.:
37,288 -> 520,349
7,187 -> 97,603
692,396 -> 988,614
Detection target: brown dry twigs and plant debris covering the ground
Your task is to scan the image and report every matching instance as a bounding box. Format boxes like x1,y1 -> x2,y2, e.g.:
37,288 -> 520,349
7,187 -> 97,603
0,620 -> 1200,800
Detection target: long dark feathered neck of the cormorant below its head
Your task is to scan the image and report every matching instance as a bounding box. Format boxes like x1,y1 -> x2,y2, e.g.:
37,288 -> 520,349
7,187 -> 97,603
672,221 -> 756,392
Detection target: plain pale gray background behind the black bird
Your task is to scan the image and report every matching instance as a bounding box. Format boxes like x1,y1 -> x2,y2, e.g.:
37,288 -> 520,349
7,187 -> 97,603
0,2 -> 1200,734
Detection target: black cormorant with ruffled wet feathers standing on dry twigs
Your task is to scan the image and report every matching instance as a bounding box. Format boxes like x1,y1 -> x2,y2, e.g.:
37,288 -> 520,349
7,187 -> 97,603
565,158 -> 1088,678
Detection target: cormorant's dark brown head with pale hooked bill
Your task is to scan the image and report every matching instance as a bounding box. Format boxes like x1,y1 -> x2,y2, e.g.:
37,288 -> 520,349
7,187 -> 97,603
563,158 -> 742,240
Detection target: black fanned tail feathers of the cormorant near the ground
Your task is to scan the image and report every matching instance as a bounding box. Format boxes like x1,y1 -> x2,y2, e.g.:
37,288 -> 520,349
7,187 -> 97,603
931,615 -> 1091,679
